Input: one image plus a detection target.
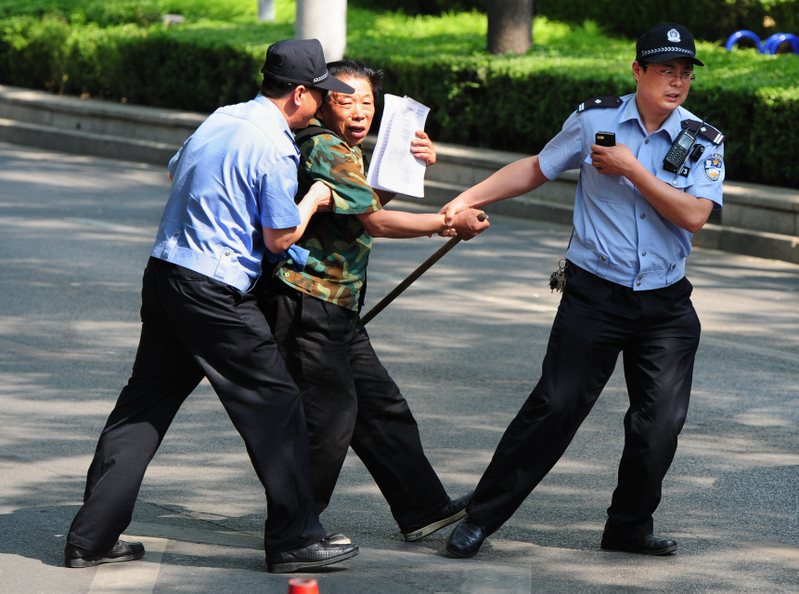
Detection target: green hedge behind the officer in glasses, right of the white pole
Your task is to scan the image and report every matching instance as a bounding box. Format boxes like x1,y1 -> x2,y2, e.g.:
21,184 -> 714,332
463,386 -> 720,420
348,14 -> 799,187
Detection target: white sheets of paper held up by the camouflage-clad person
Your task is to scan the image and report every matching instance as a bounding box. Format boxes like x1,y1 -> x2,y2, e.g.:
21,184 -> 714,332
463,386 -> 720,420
367,95 -> 430,198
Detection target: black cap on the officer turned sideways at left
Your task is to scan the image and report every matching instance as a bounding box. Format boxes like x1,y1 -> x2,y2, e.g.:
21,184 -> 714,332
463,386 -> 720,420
261,39 -> 355,95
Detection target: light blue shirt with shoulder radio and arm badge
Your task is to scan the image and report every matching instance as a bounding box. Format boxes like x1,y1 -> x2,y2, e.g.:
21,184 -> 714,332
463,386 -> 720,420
538,95 -> 724,290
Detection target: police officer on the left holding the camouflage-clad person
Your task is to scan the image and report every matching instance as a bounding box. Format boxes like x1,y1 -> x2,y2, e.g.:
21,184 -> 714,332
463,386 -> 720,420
64,40 -> 358,573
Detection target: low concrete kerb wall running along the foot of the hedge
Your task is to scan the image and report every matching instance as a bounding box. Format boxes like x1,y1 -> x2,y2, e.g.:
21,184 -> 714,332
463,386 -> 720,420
0,86 -> 799,264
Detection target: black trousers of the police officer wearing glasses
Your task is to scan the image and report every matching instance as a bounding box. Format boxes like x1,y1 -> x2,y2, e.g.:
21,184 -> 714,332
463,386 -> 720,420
467,263 -> 700,534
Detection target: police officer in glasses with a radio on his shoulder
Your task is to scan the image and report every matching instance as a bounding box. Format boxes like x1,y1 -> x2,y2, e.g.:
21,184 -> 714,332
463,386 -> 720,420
442,23 -> 724,557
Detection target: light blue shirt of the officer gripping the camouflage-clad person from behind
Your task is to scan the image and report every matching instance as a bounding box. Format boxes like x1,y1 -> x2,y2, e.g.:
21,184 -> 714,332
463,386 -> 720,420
151,95 -> 307,291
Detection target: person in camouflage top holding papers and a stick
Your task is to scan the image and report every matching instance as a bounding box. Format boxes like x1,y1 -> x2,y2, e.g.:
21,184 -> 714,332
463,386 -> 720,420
261,62 -> 488,540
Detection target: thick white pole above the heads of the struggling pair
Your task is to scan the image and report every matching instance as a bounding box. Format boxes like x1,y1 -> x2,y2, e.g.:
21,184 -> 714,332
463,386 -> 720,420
294,0 -> 347,62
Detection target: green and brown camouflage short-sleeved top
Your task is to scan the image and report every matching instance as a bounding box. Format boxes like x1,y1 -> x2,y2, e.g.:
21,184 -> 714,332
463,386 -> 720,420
277,119 -> 382,310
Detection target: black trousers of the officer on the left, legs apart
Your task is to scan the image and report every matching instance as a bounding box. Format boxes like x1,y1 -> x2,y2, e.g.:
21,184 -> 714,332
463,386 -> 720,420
67,258 -> 325,551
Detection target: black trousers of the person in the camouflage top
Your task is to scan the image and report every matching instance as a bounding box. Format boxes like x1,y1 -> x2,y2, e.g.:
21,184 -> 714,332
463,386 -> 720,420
259,278 -> 449,528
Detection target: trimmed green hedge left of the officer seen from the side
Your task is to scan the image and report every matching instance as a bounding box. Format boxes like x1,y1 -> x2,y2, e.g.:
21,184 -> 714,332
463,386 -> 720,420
0,17 -> 293,107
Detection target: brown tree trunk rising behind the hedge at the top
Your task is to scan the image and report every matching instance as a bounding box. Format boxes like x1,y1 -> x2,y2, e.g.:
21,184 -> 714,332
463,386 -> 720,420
486,0 -> 533,54
